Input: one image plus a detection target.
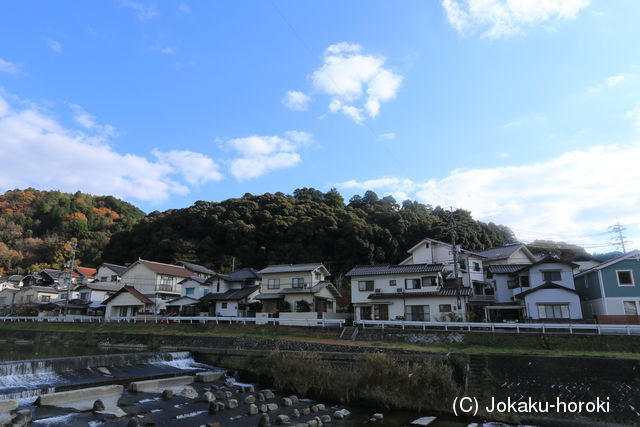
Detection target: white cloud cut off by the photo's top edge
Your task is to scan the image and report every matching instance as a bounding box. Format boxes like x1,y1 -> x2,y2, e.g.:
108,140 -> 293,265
442,0 -> 589,38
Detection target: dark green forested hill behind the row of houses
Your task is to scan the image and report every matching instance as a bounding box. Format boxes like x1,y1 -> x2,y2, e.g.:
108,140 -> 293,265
104,188 -> 514,282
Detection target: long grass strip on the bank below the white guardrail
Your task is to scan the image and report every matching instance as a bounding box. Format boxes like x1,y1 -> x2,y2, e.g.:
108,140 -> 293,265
0,322 -> 640,359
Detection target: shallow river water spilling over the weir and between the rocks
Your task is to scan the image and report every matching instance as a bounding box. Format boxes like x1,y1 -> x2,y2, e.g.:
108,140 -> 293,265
0,342 -> 490,427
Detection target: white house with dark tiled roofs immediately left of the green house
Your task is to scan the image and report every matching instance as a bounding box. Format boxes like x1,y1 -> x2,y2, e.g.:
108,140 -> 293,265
481,244 -> 582,322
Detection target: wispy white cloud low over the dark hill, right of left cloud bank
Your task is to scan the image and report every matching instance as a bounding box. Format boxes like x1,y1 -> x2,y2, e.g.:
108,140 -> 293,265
223,131 -> 311,181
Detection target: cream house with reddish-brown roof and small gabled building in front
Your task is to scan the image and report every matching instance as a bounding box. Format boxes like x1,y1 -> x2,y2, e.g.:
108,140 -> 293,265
103,259 -> 193,317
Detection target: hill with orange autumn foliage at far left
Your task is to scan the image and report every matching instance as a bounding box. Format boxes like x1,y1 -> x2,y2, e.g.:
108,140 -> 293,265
0,188 -> 145,275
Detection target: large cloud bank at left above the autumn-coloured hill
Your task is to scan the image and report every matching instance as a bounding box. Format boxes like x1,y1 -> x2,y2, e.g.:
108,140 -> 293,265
0,92 -> 221,203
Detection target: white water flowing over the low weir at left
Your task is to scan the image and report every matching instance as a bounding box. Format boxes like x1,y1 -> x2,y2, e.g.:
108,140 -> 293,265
0,351 -> 209,401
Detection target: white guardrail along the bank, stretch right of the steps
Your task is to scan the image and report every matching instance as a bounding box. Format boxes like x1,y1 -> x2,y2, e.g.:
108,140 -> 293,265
353,320 -> 640,335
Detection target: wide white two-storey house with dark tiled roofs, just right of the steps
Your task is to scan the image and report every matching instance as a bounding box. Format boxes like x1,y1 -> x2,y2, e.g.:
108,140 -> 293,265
346,263 -> 472,322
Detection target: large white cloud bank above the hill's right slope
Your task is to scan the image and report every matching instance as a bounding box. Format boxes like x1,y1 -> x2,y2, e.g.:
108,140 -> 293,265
337,142 -> 640,246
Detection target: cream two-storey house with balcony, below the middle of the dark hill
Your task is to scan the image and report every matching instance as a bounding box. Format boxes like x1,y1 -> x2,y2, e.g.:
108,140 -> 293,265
255,263 -> 340,313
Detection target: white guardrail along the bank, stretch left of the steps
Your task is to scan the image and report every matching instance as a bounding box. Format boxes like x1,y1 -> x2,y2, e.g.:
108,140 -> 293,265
0,315 -> 345,327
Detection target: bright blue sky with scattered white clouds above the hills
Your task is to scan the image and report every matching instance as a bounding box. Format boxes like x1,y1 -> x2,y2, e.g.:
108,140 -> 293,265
0,0 -> 640,252
